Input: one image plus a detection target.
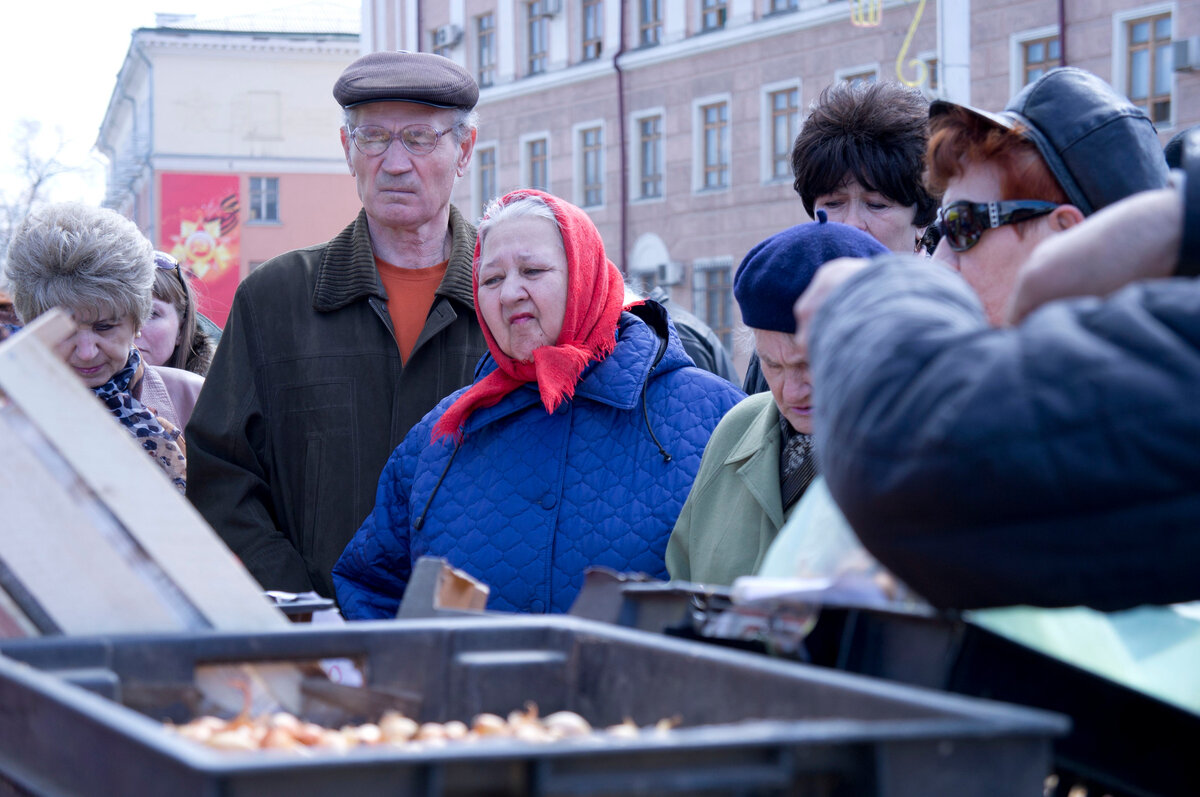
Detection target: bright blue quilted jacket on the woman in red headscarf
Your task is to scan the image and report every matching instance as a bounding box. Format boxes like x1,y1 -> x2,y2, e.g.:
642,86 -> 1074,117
334,305 -> 744,619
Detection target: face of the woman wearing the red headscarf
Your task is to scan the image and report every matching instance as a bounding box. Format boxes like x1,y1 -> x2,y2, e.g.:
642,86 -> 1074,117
479,216 -> 566,360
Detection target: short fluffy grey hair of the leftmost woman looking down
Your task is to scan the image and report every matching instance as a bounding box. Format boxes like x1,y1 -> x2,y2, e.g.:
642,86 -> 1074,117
5,202 -> 157,329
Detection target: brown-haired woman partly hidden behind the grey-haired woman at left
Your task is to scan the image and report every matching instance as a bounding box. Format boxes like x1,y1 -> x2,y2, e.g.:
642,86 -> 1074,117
137,252 -> 216,377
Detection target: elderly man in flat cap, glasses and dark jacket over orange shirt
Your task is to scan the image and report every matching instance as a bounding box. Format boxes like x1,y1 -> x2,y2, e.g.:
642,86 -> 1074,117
186,53 -> 486,597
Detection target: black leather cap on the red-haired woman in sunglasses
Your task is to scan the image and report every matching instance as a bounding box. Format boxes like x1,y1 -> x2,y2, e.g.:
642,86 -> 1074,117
929,66 -> 1166,216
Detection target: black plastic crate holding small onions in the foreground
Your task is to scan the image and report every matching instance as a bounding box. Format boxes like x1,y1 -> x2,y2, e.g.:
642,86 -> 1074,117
0,617 -> 1068,797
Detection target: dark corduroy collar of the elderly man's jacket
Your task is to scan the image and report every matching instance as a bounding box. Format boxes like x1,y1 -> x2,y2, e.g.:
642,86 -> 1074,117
312,205 -> 475,312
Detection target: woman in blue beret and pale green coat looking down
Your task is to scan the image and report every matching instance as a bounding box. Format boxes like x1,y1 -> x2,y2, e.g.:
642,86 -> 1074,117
666,210 -> 887,585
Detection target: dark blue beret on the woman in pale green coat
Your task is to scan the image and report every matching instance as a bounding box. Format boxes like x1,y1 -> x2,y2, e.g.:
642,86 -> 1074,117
733,210 -> 888,332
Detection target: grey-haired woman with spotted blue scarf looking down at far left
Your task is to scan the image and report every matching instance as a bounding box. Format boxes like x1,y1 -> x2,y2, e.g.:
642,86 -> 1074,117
5,203 -> 204,491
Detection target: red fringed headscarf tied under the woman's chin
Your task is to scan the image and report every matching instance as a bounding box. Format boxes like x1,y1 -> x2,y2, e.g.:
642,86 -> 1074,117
432,188 -> 625,441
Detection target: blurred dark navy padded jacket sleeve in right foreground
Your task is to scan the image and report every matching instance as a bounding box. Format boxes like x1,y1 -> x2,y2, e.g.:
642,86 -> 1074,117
810,256 -> 1200,610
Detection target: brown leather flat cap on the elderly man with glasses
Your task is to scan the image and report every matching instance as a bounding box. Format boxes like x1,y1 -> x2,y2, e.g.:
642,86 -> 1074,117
334,50 -> 479,110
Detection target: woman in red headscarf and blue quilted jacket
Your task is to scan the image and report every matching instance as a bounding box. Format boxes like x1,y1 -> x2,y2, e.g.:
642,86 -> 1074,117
334,190 -> 744,619
